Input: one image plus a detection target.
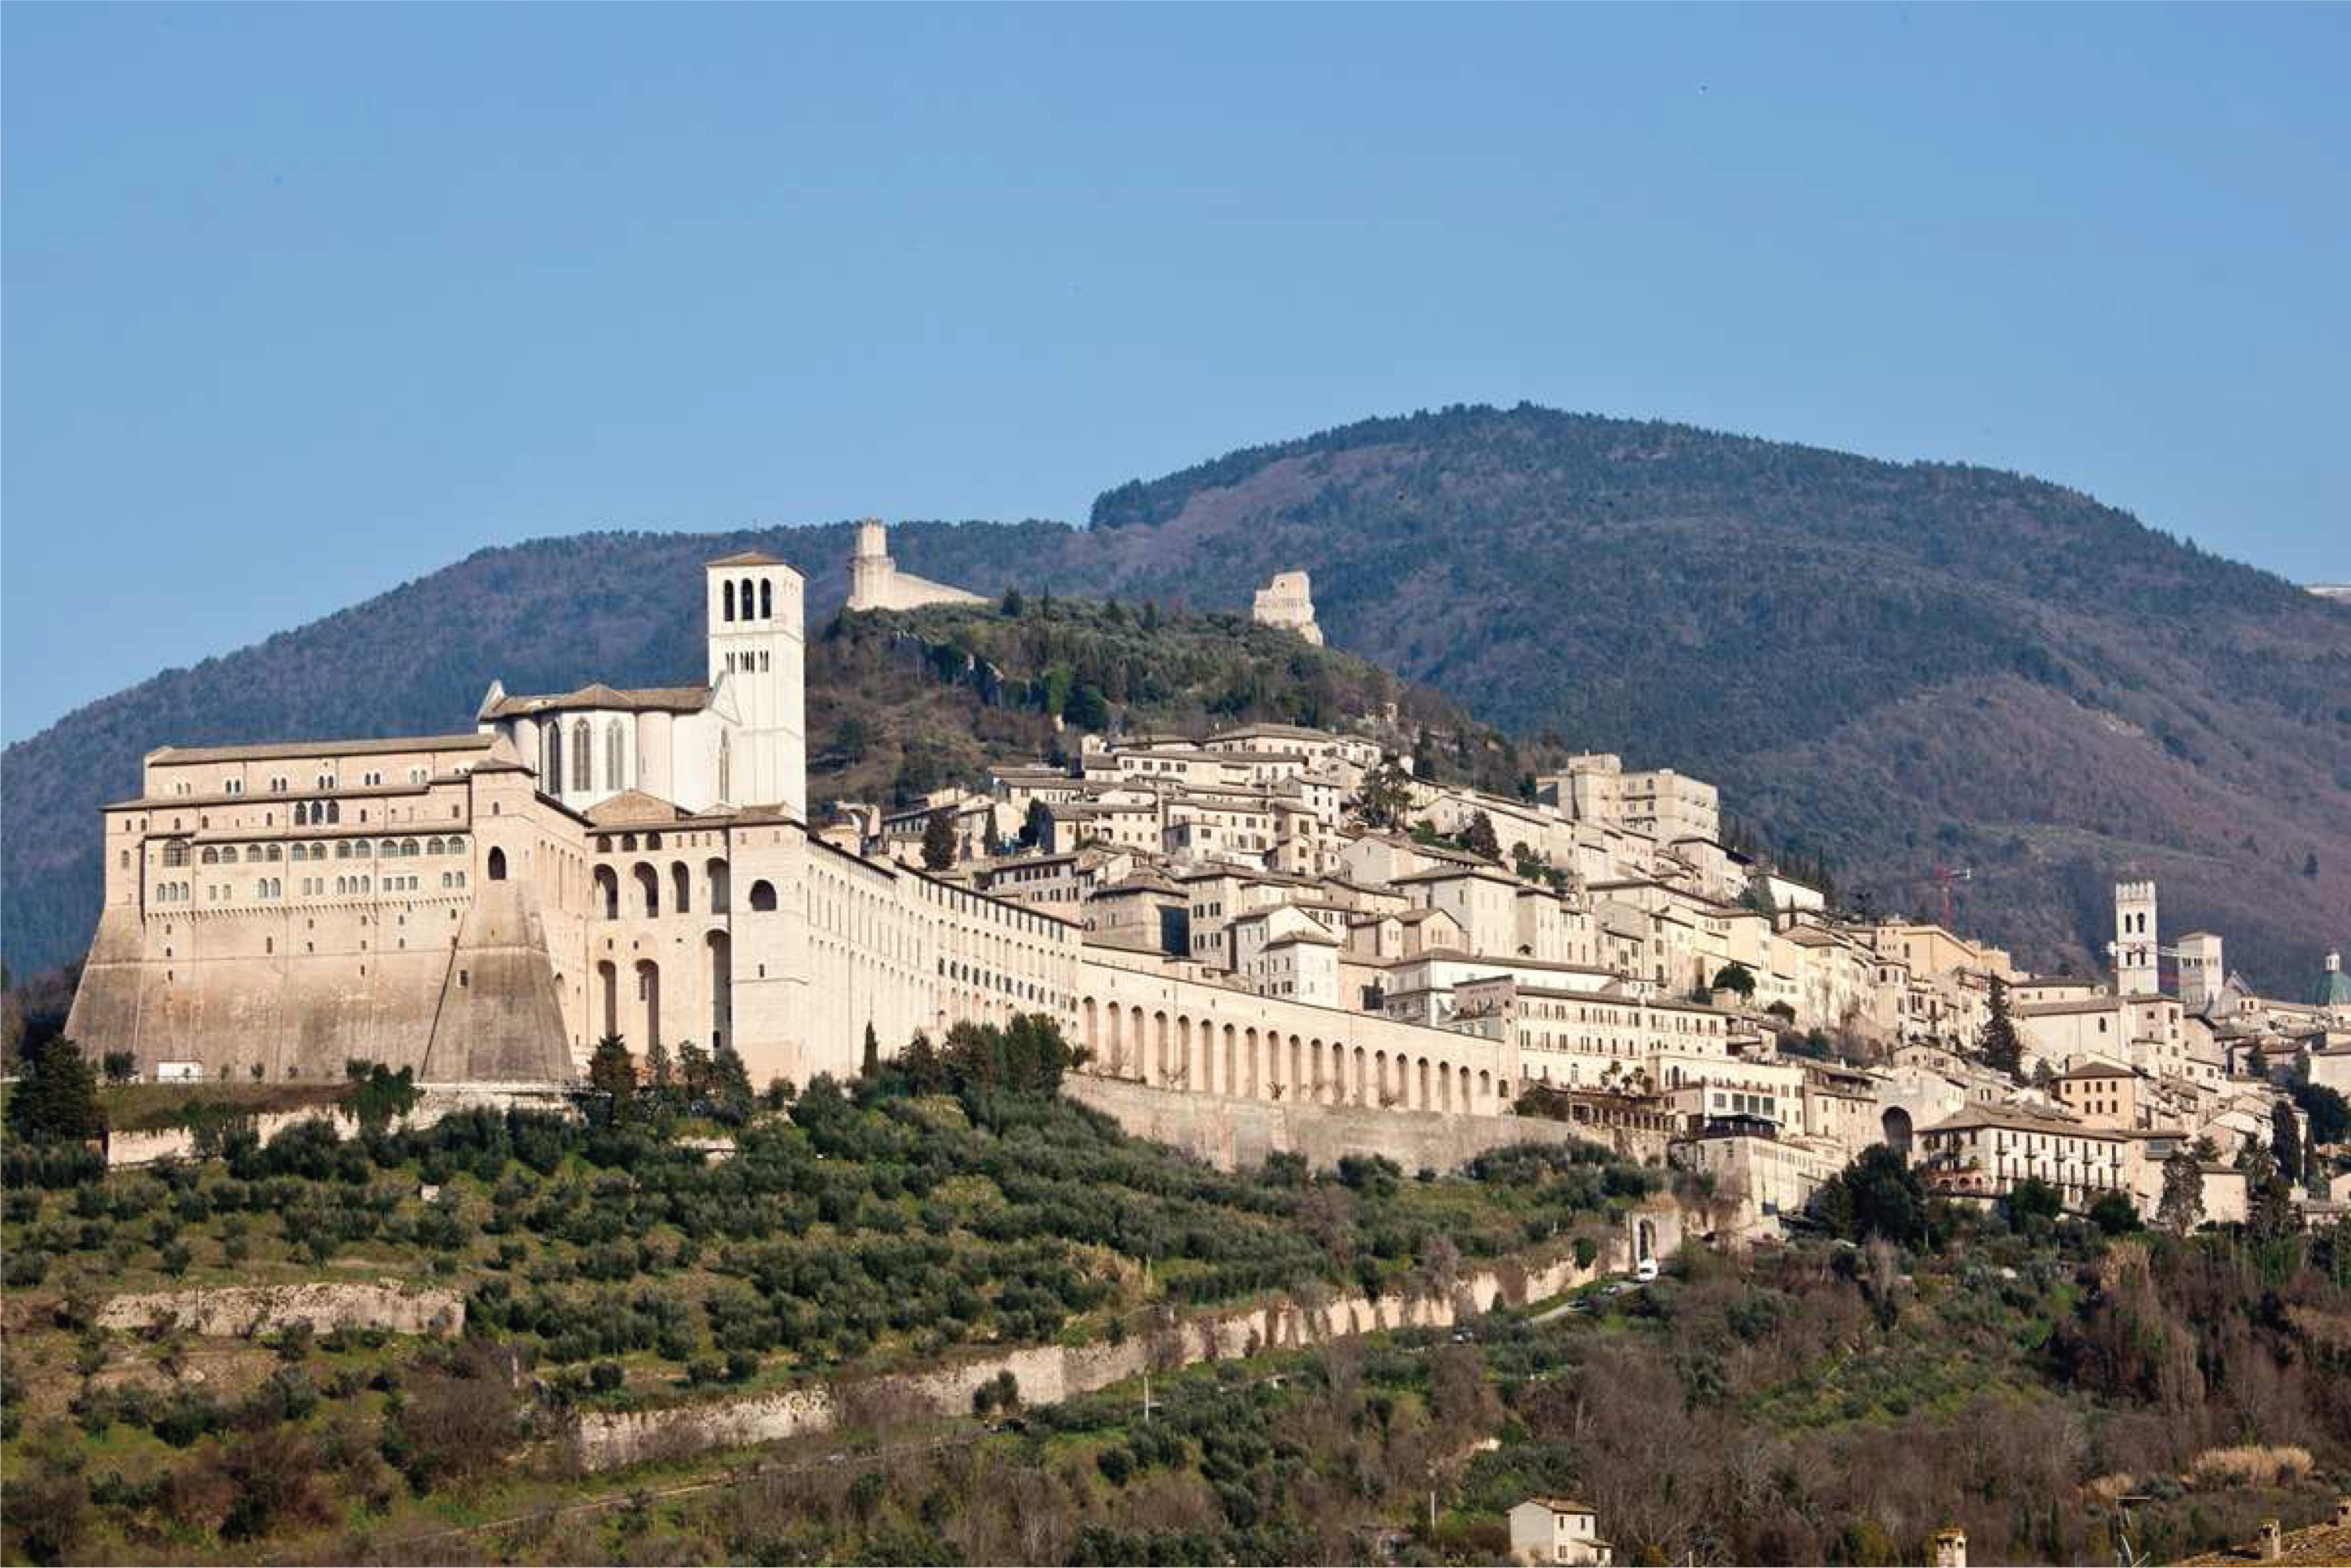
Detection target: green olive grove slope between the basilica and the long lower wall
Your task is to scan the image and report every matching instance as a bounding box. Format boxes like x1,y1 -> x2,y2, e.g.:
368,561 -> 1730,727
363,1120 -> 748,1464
0,1020 -> 1657,1561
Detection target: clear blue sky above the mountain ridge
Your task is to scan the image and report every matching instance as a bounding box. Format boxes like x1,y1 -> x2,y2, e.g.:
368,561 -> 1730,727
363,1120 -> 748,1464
0,5 -> 2351,738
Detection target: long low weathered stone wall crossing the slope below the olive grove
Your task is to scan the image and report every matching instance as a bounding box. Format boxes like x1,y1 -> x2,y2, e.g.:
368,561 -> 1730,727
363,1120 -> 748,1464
574,1234 -> 1634,1469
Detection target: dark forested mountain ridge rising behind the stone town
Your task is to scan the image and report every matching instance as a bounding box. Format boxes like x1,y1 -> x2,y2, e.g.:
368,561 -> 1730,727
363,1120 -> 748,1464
0,407 -> 2351,992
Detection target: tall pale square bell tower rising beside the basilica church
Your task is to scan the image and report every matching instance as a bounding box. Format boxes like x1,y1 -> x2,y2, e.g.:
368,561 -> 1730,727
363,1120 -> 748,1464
703,550 -> 809,820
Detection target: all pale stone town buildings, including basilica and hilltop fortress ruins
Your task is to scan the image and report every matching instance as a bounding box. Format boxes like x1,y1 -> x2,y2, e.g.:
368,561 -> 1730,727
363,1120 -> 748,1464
55,522 -> 2351,1234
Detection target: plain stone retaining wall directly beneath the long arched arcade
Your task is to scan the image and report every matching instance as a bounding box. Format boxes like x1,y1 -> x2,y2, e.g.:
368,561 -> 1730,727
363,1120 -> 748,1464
1063,1072 -> 1665,1171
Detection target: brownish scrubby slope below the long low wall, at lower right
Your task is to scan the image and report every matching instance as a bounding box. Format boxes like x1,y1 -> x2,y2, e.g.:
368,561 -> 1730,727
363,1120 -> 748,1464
538,1180 -> 2351,1563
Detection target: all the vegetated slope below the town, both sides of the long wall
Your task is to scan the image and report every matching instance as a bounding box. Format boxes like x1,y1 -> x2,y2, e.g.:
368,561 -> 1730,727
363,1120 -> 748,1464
0,1020 -> 2351,1563
